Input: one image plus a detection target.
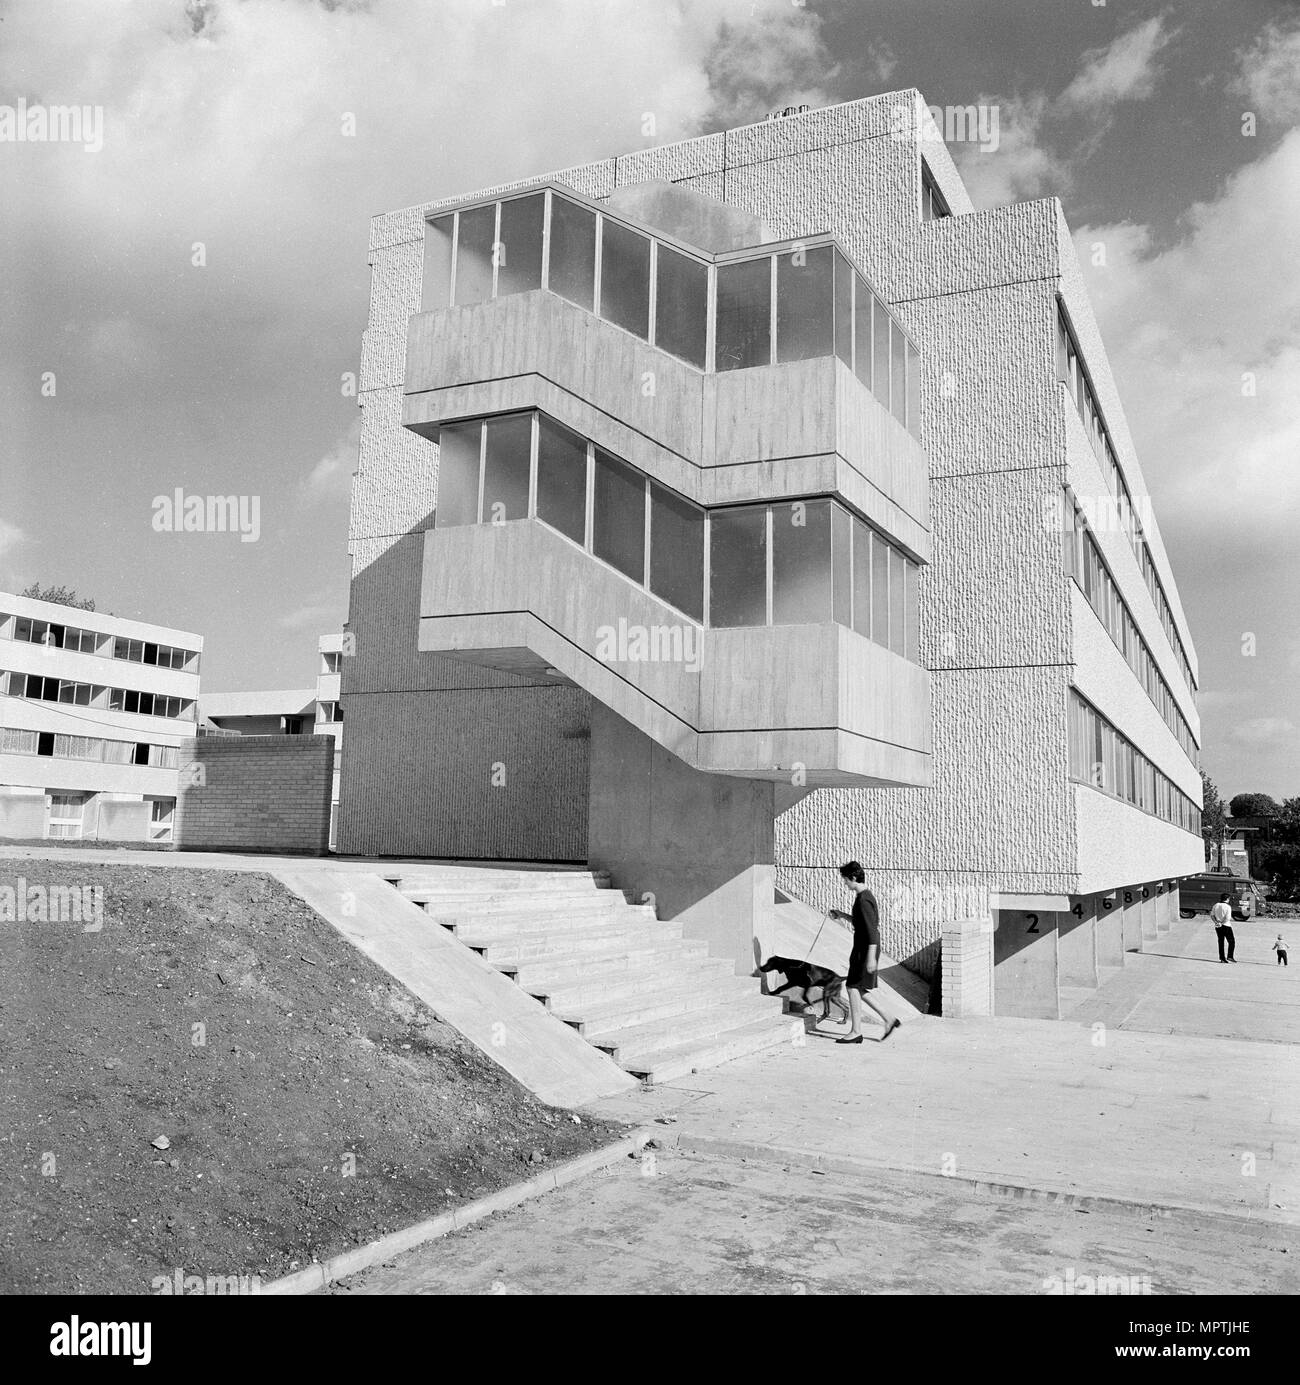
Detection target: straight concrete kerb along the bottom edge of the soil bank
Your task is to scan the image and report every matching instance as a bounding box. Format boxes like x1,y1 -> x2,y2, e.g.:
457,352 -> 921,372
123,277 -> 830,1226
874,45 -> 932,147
260,1126 -> 666,1295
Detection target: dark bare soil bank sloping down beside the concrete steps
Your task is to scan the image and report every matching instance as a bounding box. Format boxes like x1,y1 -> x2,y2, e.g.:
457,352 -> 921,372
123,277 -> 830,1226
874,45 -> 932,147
0,860 -> 623,1294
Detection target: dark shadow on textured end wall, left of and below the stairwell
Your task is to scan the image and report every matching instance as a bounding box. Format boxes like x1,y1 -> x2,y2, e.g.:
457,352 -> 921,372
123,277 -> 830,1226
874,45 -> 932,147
338,512 -> 590,863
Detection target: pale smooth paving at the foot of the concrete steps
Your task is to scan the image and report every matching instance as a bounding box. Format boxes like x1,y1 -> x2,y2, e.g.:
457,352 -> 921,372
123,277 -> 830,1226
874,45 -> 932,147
593,930 -> 1300,1224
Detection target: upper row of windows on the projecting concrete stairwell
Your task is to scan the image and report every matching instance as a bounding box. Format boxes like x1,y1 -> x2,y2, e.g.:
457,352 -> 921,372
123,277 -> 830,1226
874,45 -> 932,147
424,191 -> 921,436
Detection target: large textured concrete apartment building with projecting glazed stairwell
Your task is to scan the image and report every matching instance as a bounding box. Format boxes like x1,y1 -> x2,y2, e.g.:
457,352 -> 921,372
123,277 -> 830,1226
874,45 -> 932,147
339,91 -> 1202,1017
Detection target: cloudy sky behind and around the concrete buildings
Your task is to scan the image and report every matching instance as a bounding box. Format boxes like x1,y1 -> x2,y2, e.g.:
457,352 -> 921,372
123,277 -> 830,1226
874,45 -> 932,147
0,0 -> 1300,798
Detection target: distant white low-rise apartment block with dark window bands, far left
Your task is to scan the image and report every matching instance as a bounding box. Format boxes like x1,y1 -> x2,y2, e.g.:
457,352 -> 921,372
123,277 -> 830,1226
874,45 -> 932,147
0,593 -> 204,843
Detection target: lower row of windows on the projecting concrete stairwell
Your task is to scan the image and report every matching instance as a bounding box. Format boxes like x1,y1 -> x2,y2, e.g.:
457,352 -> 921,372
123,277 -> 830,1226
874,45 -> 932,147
433,410 -> 919,659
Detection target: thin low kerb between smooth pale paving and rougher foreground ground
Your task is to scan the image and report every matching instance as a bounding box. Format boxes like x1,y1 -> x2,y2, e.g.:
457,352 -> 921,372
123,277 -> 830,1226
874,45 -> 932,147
667,1130 -> 1300,1228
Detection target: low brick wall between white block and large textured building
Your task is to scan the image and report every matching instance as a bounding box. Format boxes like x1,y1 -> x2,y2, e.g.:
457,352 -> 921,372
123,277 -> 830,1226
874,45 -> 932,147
176,735 -> 334,855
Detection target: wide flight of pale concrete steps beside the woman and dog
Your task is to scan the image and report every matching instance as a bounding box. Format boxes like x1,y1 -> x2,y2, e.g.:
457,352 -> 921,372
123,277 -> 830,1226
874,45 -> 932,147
388,866 -> 803,1082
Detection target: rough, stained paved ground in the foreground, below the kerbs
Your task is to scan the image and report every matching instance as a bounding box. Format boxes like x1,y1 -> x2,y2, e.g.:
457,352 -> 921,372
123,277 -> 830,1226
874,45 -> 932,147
331,1141 -> 1300,1295
